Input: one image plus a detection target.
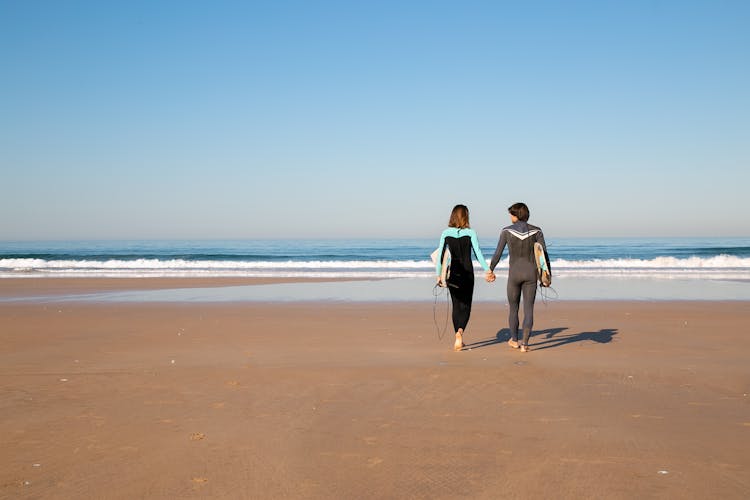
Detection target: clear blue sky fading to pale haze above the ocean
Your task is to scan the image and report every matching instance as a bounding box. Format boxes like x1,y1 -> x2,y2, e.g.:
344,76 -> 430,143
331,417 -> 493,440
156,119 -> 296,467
0,0 -> 750,241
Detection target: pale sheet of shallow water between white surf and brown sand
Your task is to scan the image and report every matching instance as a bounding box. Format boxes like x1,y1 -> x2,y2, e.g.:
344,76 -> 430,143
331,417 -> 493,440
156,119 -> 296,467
0,276 -> 750,303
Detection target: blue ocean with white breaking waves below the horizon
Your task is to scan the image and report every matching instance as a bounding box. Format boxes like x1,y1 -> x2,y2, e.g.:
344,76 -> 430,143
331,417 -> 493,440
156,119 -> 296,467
0,237 -> 750,280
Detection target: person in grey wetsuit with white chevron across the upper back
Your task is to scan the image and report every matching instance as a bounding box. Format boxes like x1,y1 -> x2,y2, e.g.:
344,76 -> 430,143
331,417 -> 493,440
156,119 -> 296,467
490,203 -> 551,352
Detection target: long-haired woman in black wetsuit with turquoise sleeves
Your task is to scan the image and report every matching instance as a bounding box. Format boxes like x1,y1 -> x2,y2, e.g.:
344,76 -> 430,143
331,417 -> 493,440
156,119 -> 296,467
435,205 -> 490,351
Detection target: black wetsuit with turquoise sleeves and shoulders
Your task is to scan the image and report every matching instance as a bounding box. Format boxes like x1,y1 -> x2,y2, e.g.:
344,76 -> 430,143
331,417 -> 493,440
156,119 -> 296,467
435,227 -> 489,331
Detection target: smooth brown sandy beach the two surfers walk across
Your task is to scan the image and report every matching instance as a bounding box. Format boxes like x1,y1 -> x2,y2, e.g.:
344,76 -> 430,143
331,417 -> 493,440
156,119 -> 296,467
0,280 -> 750,499
